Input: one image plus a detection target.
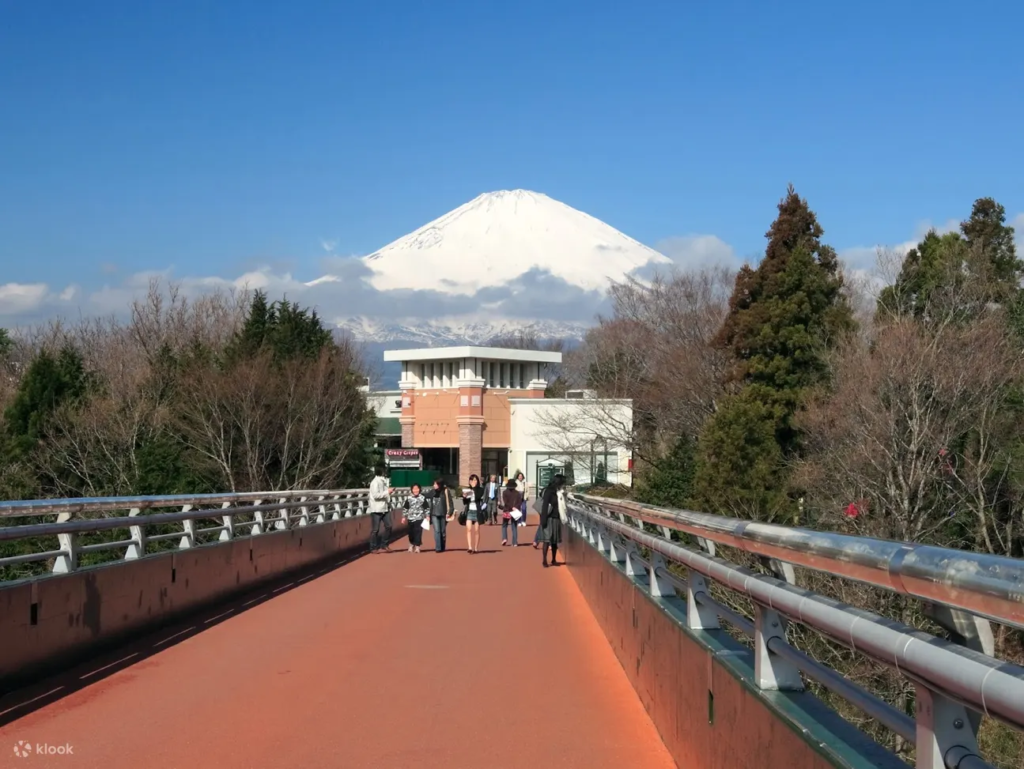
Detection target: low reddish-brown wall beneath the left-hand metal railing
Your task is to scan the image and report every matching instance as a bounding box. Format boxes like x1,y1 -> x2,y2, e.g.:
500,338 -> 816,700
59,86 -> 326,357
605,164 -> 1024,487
0,512 -> 404,689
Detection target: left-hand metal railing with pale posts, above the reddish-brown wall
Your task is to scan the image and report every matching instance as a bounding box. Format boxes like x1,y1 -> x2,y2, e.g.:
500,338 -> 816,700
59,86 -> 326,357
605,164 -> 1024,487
0,488 -> 404,579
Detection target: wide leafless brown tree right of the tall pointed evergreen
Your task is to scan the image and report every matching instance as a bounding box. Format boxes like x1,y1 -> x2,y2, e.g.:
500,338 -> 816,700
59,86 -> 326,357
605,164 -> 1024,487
798,317 -> 1019,542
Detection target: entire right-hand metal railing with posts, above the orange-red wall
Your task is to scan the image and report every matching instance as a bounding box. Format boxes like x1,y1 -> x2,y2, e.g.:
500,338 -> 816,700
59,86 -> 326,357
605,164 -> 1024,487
568,494 -> 1024,769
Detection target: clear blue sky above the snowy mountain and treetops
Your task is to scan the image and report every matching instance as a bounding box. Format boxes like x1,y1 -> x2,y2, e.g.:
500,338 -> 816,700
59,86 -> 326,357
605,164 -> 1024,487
0,0 -> 1024,319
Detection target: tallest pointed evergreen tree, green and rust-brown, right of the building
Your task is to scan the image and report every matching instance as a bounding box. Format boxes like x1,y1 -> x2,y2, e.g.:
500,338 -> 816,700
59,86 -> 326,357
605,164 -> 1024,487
694,184 -> 854,518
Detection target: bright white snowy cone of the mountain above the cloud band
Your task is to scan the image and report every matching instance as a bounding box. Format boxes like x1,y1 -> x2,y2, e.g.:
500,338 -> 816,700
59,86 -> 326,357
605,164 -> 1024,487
365,189 -> 670,295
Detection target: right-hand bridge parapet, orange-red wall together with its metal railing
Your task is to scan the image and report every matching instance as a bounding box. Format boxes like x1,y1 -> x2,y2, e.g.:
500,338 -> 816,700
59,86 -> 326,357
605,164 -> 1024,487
567,495 -> 1024,769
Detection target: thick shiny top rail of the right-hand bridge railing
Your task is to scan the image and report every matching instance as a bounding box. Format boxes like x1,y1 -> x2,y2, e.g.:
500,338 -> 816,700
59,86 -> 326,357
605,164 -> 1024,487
571,495 -> 1024,628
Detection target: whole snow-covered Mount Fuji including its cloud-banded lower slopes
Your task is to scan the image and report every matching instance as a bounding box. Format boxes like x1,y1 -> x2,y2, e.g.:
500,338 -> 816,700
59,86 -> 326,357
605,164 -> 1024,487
323,189 -> 671,346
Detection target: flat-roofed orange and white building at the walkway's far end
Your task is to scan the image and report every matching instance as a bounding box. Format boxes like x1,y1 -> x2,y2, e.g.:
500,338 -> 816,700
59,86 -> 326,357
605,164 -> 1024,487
379,346 -> 632,488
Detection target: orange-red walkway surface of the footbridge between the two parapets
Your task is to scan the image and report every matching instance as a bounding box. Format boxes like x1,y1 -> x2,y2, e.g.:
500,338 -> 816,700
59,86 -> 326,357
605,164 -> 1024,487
0,525 -> 675,769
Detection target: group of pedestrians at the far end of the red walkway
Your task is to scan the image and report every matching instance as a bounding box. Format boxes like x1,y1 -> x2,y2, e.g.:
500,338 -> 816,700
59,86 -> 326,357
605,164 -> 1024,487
369,467 -> 566,566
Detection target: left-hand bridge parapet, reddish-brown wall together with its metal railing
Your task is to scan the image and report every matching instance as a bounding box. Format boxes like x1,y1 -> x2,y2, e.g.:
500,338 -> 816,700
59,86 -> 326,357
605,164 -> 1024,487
0,488 -> 406,688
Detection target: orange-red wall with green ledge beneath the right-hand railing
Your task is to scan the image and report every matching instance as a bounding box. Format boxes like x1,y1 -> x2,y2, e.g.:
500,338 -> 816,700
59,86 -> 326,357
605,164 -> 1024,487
562,526 -> 906,769
